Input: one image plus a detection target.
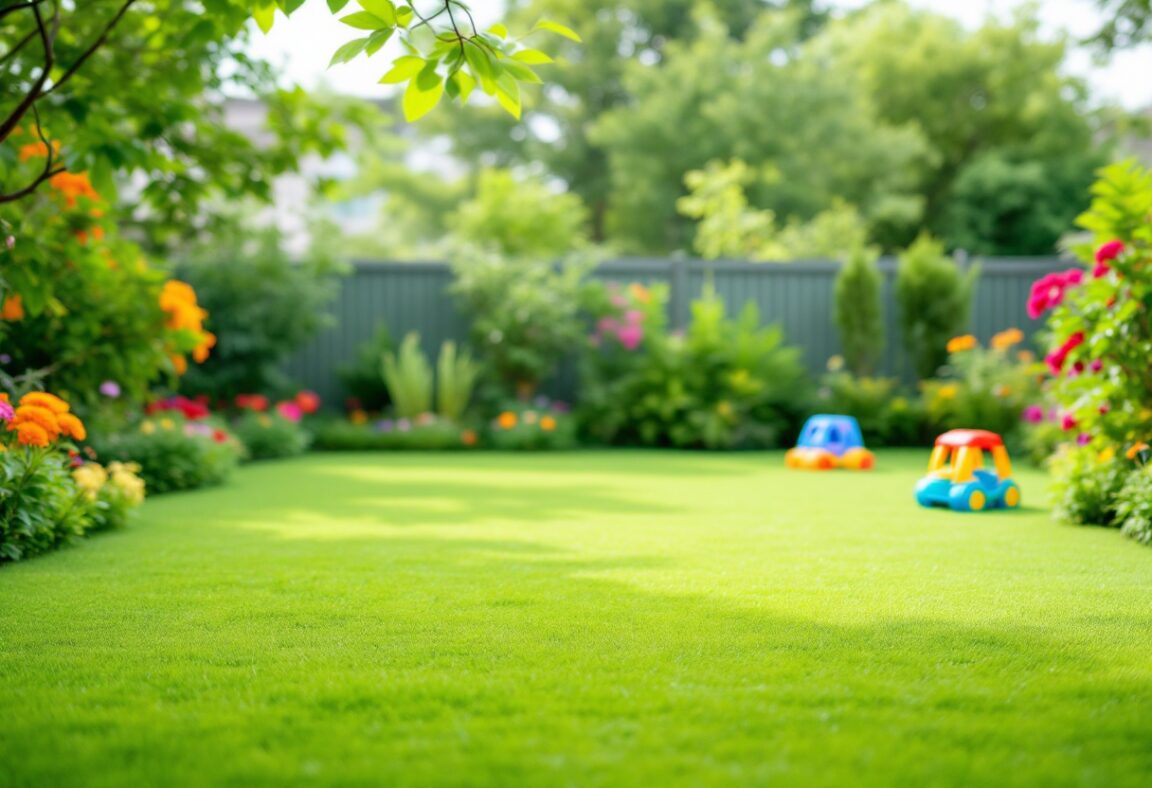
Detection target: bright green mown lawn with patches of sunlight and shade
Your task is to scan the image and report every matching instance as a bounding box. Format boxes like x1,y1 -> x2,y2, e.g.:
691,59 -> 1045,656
0,452 -> 1152,787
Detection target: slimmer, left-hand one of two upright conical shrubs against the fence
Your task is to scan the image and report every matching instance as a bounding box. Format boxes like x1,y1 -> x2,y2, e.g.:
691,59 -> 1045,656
835,247 -> 884,377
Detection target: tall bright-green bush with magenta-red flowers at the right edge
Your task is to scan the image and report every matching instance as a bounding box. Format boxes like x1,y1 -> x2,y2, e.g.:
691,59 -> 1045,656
1029,162 -> 1152,535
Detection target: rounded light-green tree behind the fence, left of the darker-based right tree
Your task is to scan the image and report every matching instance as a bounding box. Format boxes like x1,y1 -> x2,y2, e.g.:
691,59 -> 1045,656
593,14 -> 925,252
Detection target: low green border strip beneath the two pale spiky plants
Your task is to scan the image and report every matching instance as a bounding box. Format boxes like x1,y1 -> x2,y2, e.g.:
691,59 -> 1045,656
314,414 -> 478,452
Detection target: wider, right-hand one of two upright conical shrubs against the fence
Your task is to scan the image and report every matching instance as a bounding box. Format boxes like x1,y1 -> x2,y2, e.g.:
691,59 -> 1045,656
896,235 -> 979,380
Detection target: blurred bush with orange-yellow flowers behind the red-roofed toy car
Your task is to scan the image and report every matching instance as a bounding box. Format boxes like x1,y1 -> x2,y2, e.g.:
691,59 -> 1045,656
922,328 -> 1041,448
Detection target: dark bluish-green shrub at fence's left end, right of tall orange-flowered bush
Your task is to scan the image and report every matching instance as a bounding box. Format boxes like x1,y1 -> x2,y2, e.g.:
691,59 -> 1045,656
176,226 -> 341,401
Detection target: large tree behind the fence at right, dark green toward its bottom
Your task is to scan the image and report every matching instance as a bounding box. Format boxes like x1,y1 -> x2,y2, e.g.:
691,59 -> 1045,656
813,1 -> 1107,253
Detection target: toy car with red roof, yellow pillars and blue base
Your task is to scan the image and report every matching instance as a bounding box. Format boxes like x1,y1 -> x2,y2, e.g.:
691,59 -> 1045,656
916,430 -> 1020,512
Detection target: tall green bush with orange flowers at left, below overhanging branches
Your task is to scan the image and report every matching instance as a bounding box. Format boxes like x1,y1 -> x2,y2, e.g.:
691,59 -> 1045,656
0,156 -> 213,407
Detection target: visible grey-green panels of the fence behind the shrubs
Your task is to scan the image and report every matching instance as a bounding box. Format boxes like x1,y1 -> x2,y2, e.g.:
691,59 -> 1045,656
287,258 -> 1069,402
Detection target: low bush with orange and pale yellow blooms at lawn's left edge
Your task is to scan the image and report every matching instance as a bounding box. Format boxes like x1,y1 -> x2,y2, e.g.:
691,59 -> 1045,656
0,392 -> 144,562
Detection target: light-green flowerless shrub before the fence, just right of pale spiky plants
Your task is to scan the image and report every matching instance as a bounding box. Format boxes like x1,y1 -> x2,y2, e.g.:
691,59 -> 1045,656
452,252 -> 594,400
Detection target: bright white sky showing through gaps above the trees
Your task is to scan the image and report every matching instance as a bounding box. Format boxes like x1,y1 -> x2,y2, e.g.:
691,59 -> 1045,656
251,0 -> 1152,109
